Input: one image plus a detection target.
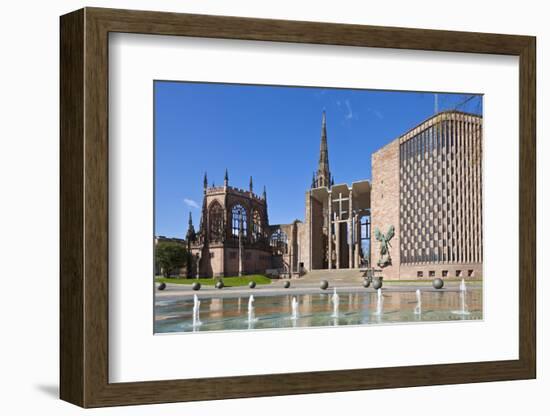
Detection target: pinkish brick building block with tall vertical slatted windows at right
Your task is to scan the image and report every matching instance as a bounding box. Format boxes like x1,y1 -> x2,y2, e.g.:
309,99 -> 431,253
372,111 -> 483,279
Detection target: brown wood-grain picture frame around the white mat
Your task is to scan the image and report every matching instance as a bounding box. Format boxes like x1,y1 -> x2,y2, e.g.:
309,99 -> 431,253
60,8 -> 536,407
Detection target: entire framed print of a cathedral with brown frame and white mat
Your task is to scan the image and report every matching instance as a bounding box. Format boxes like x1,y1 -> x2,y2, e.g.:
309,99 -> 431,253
60,8 -> 536,407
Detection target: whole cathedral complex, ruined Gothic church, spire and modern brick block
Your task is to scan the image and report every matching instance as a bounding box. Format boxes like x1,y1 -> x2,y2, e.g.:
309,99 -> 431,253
186,111 -> 483,279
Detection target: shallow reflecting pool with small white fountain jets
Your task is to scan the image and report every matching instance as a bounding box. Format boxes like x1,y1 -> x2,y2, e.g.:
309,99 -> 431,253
154,288 -> 482,333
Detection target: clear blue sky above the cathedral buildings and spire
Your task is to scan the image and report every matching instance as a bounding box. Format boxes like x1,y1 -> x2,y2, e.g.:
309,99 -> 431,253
154,81 -> 482,238
